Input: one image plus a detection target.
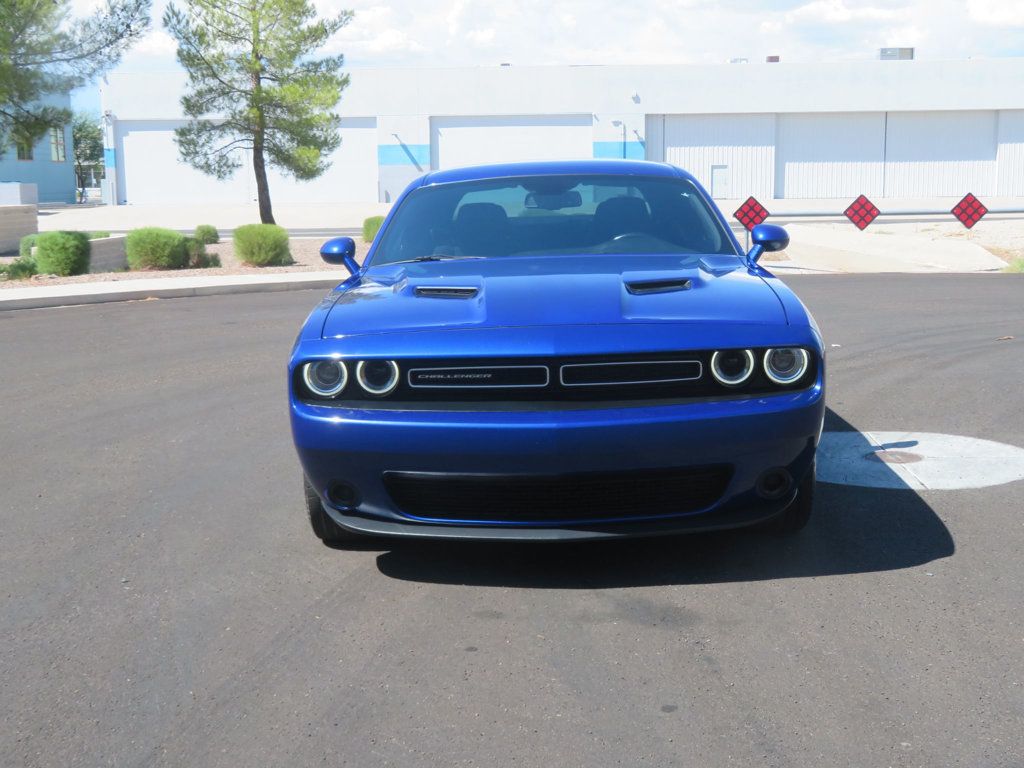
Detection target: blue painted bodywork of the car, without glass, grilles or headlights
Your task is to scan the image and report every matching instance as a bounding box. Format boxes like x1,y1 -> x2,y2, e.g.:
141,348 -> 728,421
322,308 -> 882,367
289,161 -> 825,539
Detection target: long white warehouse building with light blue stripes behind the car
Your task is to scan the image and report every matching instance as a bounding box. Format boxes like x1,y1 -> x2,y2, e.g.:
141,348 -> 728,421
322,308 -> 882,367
101,58 -> 1024,204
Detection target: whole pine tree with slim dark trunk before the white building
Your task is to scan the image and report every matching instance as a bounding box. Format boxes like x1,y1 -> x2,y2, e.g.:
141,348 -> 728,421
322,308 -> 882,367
164,0 -> 352,223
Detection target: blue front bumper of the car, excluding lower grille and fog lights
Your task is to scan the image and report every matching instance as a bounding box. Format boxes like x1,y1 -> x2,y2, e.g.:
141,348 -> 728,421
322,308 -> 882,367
291,371 -> 824,541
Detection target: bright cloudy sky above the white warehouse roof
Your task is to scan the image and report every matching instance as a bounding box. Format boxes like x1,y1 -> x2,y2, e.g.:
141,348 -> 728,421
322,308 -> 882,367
73,0 -> 1024,112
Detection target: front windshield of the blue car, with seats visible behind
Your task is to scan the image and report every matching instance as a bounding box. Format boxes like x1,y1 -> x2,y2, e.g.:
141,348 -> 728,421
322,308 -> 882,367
373,174 -> 737,264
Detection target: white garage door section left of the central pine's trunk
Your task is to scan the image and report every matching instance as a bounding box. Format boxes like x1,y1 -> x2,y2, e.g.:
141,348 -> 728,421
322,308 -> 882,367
116,120 -> 252,205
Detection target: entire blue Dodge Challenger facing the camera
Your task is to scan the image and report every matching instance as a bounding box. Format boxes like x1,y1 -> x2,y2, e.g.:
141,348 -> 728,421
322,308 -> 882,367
289,160 -> 825,544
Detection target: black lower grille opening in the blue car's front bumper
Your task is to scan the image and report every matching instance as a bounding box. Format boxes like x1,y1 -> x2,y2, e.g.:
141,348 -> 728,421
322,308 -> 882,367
384,465 -> 732,524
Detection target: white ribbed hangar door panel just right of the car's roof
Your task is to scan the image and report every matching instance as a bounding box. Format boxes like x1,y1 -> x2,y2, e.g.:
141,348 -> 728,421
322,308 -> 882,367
647,115 -> 775,199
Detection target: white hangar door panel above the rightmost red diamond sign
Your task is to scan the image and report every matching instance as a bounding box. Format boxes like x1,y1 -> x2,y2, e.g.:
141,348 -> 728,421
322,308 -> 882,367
885,112 -> 996,198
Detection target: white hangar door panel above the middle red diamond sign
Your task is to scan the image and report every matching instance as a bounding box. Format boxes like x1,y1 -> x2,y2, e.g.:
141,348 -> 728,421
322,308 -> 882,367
775,112 -> 886,200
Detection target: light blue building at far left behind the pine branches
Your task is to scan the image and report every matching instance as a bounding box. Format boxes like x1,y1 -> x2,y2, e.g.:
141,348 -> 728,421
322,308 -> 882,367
0,95 -> 77,203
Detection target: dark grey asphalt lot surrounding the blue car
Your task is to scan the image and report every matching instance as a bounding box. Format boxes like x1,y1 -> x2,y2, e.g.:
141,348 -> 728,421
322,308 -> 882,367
6,275 -> 1024,768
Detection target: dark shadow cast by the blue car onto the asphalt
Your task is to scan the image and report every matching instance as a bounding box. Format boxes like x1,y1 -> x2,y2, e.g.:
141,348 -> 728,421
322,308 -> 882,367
377,411 -> 955,589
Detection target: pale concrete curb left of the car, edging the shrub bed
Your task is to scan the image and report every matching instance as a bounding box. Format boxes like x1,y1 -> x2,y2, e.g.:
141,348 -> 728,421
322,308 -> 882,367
0,271 -> 347,311
